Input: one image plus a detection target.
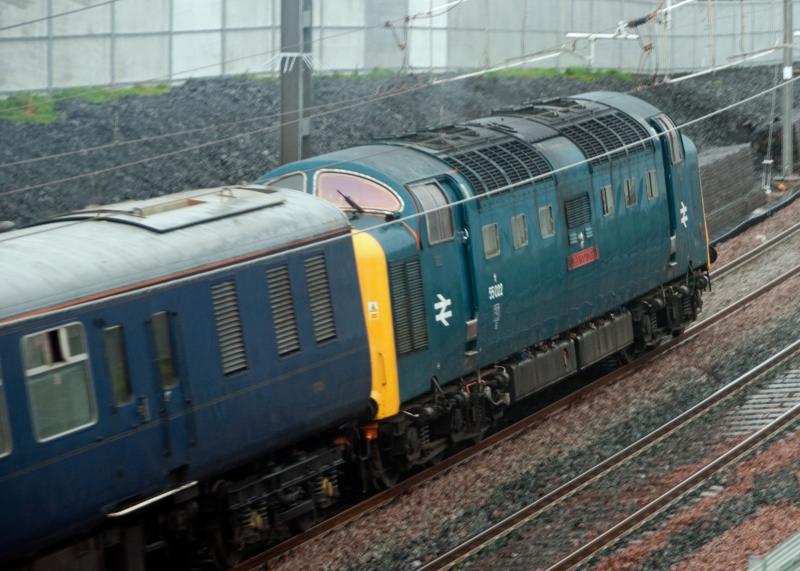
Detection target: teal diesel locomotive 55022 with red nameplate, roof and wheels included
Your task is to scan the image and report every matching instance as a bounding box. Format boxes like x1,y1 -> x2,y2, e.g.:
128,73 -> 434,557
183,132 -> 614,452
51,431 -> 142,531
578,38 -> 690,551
262,92 -> 710,470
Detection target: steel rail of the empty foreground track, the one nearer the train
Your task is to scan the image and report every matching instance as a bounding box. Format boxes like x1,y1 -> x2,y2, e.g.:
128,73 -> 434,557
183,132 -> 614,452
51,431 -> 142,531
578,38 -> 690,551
419,330 -> 800,571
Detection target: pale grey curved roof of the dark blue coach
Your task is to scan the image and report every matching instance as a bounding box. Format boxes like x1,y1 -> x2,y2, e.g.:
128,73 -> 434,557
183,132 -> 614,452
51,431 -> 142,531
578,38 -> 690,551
0,185 -> 349,320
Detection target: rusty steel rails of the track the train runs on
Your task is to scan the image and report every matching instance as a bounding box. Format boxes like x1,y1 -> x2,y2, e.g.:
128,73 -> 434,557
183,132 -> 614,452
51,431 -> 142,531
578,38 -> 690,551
228,224 -> 800,571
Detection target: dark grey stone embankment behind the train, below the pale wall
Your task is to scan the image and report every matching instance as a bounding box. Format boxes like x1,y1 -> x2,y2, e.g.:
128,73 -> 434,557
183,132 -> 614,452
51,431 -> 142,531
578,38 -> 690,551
0,68 -> 800,223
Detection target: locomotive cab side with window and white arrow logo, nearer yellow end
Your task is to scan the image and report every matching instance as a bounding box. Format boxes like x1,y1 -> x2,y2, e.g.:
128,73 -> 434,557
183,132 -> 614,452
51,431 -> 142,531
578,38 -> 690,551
409,181 -> 477,378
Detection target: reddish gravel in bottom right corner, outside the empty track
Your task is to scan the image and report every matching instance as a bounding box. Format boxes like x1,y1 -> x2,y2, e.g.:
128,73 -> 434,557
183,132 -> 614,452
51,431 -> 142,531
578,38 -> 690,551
587,423 -> 800,571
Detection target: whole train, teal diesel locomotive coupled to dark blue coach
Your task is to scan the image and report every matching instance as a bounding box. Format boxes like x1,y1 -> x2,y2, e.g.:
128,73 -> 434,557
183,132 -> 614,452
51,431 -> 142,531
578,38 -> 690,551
0,93 -> 712,569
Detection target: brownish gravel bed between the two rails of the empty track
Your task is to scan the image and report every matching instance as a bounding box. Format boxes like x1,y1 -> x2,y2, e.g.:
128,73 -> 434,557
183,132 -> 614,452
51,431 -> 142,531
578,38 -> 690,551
462,355 -> 800,569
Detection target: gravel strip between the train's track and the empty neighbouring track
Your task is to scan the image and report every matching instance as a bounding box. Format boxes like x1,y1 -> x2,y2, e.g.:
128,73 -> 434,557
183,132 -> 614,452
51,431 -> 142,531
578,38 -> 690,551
268,212 -> 800,570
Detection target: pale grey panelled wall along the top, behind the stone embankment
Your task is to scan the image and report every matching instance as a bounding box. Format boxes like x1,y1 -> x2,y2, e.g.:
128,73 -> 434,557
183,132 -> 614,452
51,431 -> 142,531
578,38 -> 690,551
0,0 -> 800,93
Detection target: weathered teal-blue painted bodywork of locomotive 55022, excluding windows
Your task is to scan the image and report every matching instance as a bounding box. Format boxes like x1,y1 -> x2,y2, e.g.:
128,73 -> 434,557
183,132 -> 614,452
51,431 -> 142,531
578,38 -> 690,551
261,92 -> 708,402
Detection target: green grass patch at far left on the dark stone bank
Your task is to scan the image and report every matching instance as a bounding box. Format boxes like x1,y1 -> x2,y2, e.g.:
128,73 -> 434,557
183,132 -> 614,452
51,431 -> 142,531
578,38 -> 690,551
0,83 -> 171,125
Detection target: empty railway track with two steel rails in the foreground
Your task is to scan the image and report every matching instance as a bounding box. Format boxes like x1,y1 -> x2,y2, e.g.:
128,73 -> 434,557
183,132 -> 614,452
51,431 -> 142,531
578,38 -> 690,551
420,339 -> 800,571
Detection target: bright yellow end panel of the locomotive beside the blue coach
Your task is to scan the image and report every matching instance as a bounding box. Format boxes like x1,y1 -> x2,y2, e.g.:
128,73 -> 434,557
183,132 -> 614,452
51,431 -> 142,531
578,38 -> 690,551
353,232 -> 400,419
